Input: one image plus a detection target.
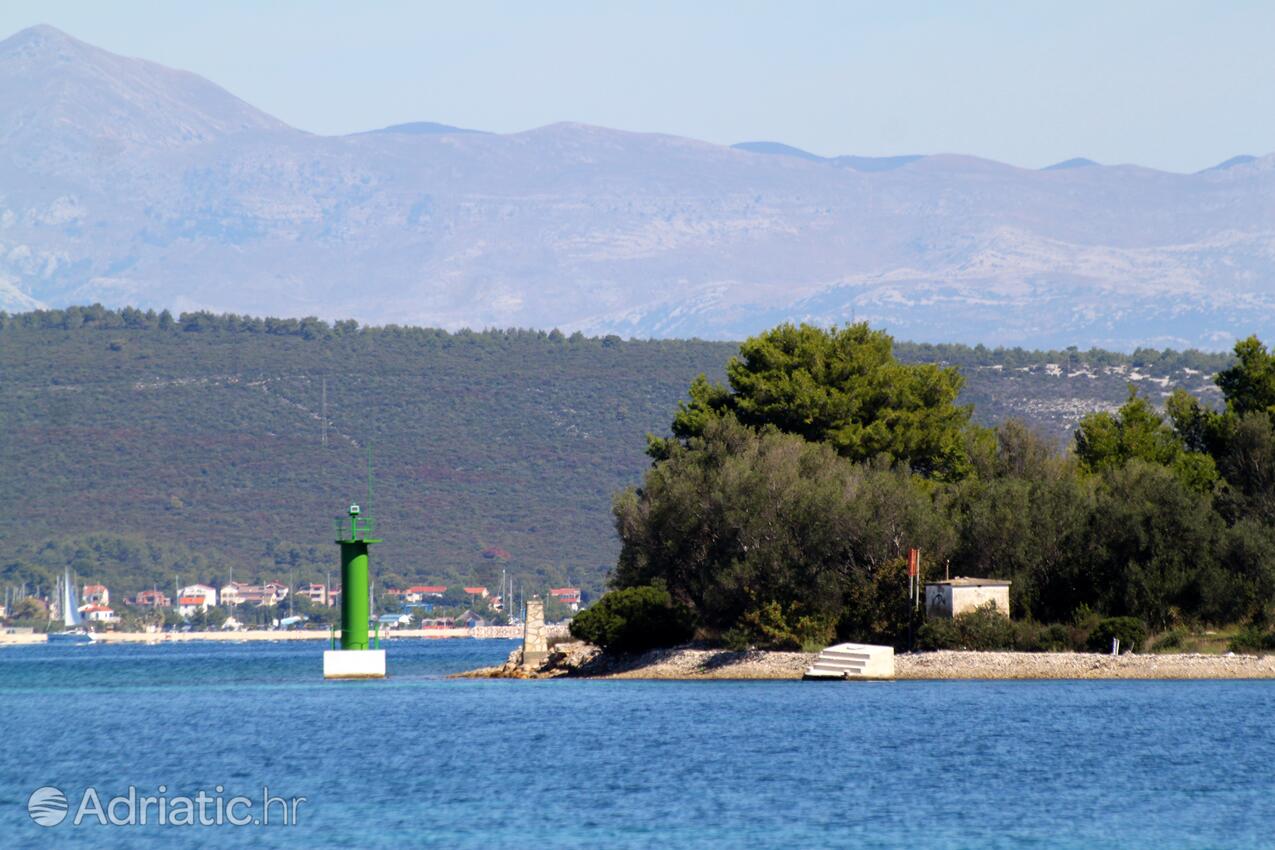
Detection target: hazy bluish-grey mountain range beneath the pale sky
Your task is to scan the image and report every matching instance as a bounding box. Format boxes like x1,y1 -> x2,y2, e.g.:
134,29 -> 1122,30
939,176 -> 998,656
0,25 -> 1275,350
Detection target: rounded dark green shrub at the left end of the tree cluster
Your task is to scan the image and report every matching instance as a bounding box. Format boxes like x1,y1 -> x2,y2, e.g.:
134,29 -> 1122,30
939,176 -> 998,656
571,585 -> 695,652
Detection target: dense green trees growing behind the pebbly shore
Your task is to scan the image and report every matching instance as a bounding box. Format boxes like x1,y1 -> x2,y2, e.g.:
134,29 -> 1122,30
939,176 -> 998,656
583,325 -> 1275,647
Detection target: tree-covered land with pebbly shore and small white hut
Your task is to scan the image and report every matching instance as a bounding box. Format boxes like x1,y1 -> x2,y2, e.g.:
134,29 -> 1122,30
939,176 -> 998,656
464,324 -> 1275,678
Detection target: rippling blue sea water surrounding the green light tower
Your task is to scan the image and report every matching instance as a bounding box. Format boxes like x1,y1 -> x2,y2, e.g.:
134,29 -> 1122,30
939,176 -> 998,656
0,640 -> 1275,850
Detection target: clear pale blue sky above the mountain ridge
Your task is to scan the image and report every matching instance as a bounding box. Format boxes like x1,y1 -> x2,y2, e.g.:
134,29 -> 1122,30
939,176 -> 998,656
0,0 -> 1275,172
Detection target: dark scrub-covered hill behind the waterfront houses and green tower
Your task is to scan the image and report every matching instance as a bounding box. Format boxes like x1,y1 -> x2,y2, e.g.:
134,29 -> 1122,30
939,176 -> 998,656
0,307 -> 1229,593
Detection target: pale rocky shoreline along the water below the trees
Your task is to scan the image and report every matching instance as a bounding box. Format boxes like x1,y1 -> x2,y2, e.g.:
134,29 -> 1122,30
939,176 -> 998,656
459,644 -> 1275,681
